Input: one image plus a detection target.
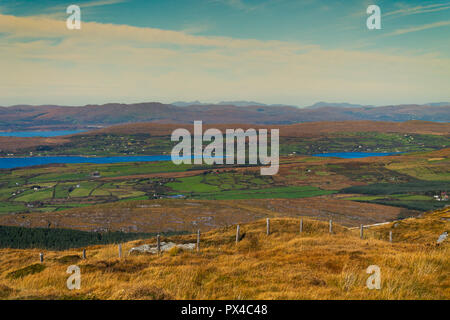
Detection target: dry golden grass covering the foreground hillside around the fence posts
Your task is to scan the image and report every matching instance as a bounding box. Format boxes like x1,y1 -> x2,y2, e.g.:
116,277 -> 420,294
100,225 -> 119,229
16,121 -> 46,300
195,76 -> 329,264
0,209 -> 450,299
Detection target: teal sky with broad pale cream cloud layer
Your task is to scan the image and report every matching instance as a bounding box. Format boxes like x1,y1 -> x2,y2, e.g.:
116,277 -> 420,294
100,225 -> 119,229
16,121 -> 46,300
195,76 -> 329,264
0,0 -> 450,106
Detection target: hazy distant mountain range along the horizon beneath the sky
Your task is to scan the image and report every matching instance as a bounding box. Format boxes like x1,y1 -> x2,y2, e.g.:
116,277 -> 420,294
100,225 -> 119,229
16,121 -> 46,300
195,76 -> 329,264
0,102 -> 450,131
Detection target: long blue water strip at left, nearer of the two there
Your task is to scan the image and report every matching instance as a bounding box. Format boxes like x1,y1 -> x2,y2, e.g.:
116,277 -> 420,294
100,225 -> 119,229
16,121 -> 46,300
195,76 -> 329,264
0,155 -> 171,169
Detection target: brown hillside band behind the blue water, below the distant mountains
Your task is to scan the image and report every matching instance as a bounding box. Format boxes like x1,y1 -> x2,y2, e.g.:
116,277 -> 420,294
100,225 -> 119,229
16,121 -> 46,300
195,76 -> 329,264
0,119 -> 450,155
